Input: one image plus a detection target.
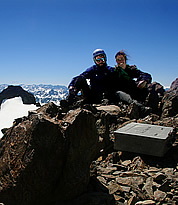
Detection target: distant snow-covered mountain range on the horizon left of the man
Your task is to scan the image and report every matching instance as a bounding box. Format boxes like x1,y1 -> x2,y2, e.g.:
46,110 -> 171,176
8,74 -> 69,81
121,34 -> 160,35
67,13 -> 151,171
0,84 -> 68,105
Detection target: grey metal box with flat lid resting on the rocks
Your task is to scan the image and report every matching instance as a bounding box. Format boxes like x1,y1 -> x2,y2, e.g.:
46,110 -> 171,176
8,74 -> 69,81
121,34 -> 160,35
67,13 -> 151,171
114,122 -> 175,157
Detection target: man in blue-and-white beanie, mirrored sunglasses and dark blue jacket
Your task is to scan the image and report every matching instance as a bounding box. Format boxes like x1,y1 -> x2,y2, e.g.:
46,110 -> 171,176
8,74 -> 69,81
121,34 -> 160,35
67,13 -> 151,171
60,49 -> 112,106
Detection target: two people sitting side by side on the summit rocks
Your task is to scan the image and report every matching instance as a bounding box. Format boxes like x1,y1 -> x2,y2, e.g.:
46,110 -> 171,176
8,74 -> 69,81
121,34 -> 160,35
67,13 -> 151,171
61,49 -> 152,115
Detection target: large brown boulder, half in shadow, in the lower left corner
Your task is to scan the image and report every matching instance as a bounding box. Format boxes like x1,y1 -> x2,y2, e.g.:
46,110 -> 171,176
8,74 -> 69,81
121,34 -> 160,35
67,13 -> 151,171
0,115 -> 65,205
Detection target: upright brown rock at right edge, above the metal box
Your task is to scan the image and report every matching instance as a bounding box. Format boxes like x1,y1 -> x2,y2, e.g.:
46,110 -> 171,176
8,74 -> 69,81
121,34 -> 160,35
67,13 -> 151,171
161,78 -> 178,118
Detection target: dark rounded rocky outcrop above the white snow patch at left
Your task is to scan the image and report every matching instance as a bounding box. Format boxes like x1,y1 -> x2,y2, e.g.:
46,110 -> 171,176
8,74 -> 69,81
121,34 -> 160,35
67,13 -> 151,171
0,85 -> 36,105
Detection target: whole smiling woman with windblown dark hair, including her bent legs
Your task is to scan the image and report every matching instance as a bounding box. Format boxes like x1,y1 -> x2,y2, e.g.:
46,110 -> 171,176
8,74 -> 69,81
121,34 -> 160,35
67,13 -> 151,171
105,51 -> 152,116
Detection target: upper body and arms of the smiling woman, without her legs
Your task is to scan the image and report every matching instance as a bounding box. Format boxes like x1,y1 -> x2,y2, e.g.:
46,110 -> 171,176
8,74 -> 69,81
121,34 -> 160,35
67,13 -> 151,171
113,50 -> 152,103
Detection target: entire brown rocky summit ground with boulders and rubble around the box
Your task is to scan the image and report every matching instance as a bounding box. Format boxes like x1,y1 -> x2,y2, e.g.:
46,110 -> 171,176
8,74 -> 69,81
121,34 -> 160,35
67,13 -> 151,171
0,79 -> 178,205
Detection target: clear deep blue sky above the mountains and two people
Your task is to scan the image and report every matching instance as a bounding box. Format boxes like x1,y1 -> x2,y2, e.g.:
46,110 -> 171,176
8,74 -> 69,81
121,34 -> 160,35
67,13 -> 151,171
0,0 -> 178,87
